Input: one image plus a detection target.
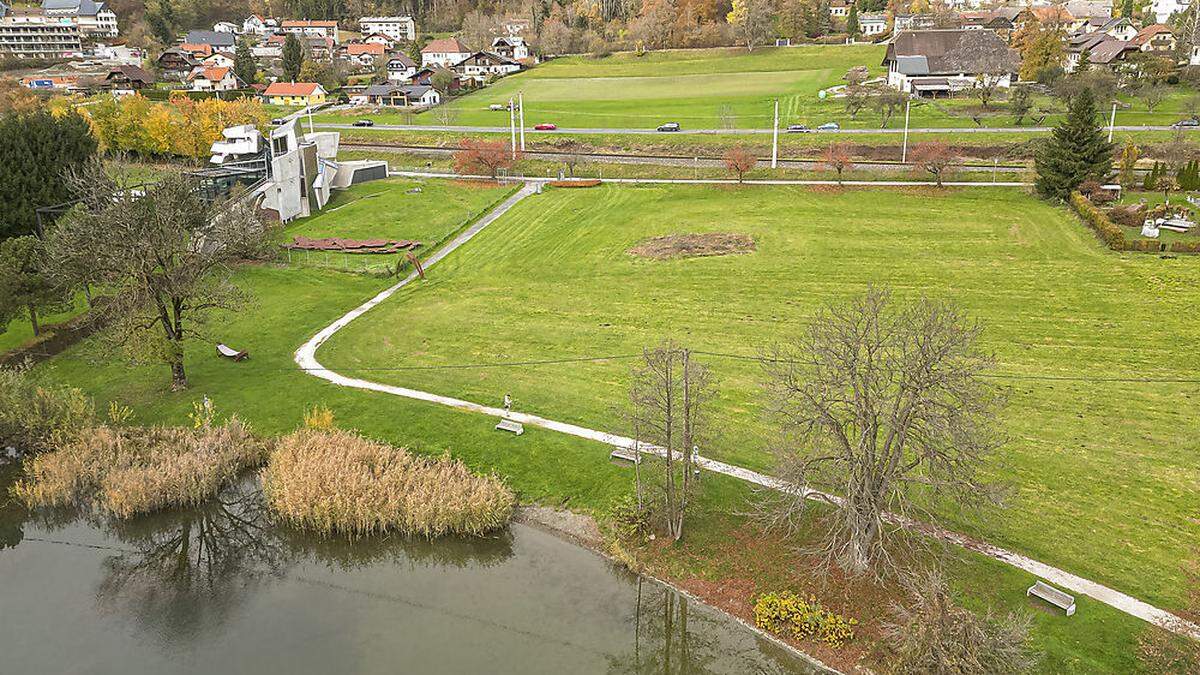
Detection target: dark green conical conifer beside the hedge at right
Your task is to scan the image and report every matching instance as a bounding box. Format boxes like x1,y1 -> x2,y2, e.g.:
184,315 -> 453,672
1034,89 -> 1114,201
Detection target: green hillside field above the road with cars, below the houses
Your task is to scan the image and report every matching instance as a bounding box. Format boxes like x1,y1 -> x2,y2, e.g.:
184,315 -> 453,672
316,44 -> 1196,129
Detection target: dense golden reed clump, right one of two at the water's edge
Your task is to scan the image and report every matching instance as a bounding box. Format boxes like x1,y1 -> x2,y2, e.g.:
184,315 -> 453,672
262,429 -> 515,538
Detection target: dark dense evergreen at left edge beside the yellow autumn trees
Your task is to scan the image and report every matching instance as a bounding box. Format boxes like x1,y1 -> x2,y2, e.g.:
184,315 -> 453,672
0,109 -> 96,239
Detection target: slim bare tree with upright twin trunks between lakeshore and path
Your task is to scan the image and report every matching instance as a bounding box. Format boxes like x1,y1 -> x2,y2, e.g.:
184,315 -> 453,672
629,344 -> 712,540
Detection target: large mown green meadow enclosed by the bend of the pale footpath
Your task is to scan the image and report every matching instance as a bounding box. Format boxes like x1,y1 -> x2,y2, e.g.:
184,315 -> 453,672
318,180 -> 1200,607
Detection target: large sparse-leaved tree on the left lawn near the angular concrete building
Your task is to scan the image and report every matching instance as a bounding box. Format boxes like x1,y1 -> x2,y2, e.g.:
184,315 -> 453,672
48,162 -> 266,389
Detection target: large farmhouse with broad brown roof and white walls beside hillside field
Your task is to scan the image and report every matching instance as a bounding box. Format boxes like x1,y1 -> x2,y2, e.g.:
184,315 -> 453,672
882,29 -> 1021,96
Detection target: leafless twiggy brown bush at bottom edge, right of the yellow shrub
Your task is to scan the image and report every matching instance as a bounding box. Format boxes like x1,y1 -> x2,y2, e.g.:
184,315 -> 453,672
883,571 -> 1038,675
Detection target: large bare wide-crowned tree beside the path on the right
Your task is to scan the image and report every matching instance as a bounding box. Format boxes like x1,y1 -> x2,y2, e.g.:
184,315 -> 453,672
763,288 -> 1001,575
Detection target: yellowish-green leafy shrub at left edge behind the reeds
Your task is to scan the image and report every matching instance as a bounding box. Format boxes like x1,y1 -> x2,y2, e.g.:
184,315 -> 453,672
0,368 -> 95,452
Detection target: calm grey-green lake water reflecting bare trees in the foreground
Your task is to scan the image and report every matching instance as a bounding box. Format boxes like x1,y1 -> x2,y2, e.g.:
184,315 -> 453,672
0,466 -> 811,675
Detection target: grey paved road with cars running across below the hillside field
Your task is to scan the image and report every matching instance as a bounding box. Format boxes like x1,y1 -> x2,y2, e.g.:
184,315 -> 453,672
316,123 -> 1200,138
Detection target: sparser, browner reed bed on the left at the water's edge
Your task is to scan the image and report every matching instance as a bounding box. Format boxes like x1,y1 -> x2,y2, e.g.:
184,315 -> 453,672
13,417 -> 266,518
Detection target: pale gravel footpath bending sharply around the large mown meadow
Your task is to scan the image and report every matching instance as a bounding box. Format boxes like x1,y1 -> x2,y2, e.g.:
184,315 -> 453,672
294,172 -> 1200,640
